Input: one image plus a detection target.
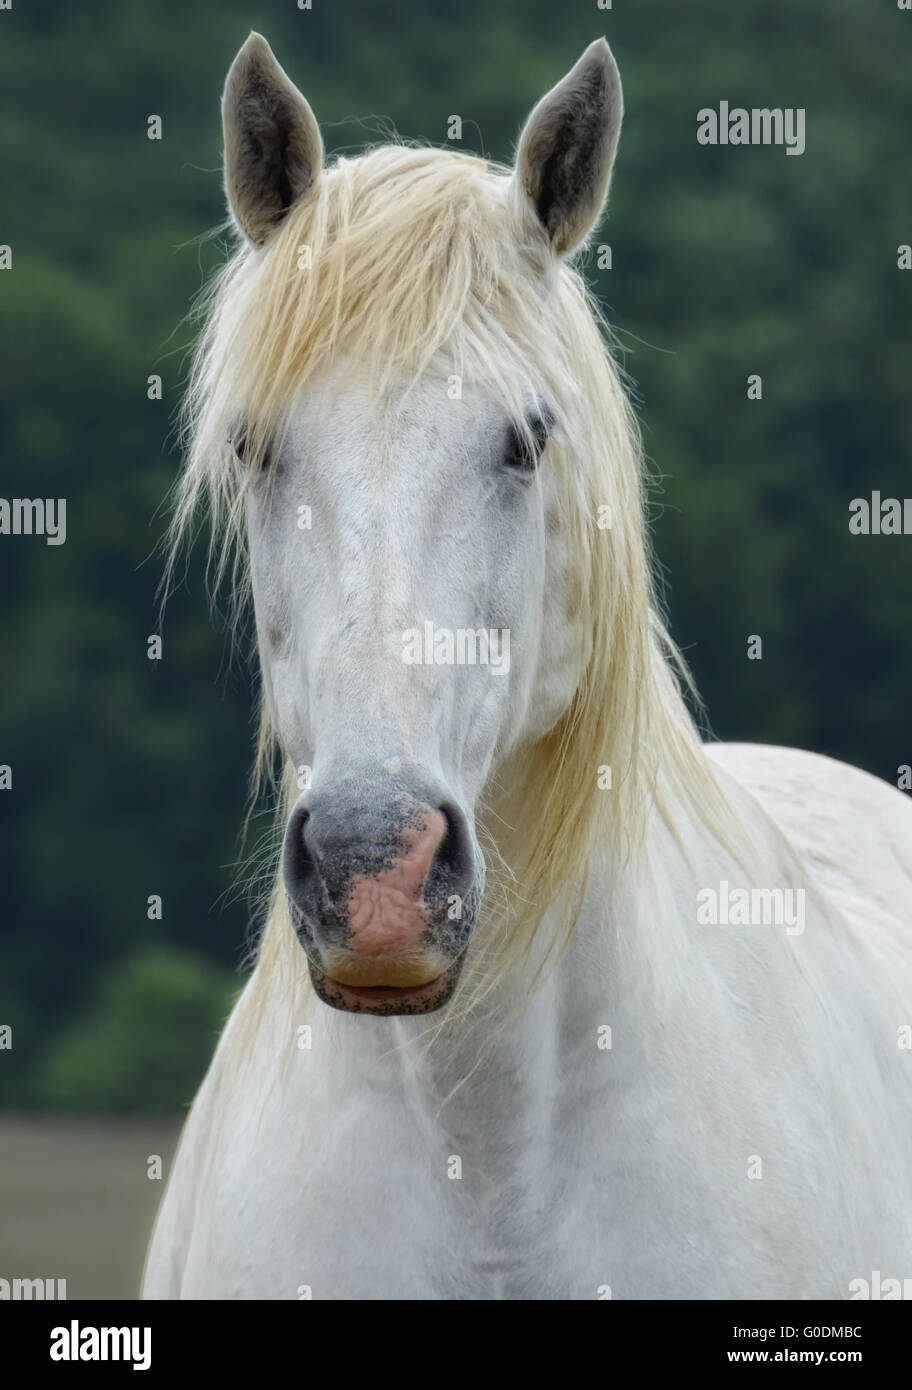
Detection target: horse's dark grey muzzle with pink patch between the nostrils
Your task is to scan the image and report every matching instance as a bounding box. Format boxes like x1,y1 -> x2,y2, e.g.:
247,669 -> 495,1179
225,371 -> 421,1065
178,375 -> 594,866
282,774 -> 484,1015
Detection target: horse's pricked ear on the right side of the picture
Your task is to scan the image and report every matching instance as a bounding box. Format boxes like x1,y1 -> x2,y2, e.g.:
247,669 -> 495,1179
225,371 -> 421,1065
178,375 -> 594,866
514,39 -> 624,256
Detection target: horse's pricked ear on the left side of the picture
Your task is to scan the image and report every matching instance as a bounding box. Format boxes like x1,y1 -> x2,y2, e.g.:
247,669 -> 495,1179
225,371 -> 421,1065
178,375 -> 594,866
221,33 -> 323,246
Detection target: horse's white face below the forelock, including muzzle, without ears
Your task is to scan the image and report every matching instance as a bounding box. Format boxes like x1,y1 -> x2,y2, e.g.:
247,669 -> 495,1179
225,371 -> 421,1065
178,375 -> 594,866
247,373 -> 573,1013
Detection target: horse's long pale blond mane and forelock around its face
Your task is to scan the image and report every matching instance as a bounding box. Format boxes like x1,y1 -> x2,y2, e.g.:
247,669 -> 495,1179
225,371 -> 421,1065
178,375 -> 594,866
170,145 -> 738,1039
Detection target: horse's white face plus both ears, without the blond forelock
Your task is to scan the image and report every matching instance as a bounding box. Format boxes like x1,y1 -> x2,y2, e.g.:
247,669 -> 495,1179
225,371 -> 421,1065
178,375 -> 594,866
222,35 -> 623,1013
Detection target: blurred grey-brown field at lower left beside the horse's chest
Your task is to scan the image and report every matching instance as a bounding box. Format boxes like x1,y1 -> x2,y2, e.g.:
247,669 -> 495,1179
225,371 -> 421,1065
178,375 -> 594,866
0,1115 -> 181,1298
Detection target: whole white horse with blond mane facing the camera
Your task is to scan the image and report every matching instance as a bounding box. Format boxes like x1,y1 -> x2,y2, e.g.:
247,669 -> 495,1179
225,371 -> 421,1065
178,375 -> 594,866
143,35 -> 912,1300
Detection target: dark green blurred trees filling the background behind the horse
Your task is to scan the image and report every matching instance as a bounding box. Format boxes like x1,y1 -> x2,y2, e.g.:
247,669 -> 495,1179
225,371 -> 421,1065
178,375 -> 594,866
0,0 -> 912,1106
